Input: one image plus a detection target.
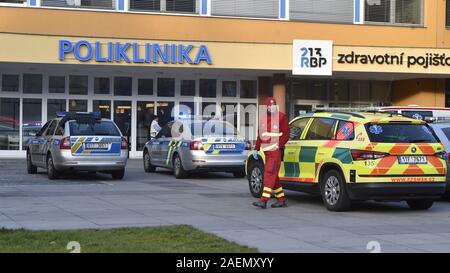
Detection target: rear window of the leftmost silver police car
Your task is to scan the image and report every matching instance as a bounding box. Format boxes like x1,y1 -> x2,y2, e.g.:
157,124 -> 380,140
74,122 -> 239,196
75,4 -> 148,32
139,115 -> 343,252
69,120 -> 120,136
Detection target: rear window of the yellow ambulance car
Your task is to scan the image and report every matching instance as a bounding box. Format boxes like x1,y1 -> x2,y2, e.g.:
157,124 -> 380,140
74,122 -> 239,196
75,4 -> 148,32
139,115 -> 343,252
366,123 -> 438,143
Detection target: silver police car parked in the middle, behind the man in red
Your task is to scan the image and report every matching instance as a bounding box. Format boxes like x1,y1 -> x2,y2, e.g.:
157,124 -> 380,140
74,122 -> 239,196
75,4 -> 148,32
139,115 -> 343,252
143,120 -> 251,178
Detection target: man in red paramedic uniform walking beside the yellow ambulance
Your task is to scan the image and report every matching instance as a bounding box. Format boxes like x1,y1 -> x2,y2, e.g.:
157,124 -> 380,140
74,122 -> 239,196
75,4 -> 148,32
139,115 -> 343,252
253,97 -> 289,209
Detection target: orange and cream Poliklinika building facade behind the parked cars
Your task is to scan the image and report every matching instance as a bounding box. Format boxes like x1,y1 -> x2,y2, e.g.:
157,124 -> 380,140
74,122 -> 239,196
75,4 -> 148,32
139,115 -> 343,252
0,0 -> 450,157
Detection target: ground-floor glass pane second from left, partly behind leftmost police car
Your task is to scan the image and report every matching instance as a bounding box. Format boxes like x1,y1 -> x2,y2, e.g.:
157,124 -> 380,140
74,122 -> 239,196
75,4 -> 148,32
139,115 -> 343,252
22,99 -> 42,150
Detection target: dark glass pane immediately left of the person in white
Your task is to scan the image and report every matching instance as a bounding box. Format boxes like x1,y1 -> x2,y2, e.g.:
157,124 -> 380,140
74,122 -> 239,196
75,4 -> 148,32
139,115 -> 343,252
136,101 -> 155,151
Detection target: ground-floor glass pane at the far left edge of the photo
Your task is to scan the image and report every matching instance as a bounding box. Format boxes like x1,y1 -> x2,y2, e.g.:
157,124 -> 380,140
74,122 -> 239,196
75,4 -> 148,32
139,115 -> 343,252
0,98 -> 20,150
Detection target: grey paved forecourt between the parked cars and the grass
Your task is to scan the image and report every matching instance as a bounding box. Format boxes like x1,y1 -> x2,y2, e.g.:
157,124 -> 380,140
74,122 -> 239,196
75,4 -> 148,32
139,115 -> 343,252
0,159 -> 450,252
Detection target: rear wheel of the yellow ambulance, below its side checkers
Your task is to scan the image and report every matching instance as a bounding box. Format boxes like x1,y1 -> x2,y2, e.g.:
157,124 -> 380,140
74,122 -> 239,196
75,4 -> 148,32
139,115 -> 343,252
320,170 -> 351,211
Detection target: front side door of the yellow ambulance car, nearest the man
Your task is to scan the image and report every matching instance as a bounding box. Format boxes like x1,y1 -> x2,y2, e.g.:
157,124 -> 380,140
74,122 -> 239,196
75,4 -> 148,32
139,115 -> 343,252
279,118 -> 311,180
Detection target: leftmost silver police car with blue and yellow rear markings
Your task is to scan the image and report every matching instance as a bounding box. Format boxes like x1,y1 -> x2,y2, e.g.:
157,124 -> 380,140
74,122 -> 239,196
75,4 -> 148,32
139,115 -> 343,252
27,112 -> 128,179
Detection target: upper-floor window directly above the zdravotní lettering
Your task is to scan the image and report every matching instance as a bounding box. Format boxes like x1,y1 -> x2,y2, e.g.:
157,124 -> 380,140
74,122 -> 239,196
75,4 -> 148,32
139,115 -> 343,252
365,0 -> 423,25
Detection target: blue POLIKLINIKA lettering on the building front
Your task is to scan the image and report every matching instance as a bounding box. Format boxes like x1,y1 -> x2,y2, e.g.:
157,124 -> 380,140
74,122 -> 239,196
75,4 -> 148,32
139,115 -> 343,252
59,40 -> 212,65
